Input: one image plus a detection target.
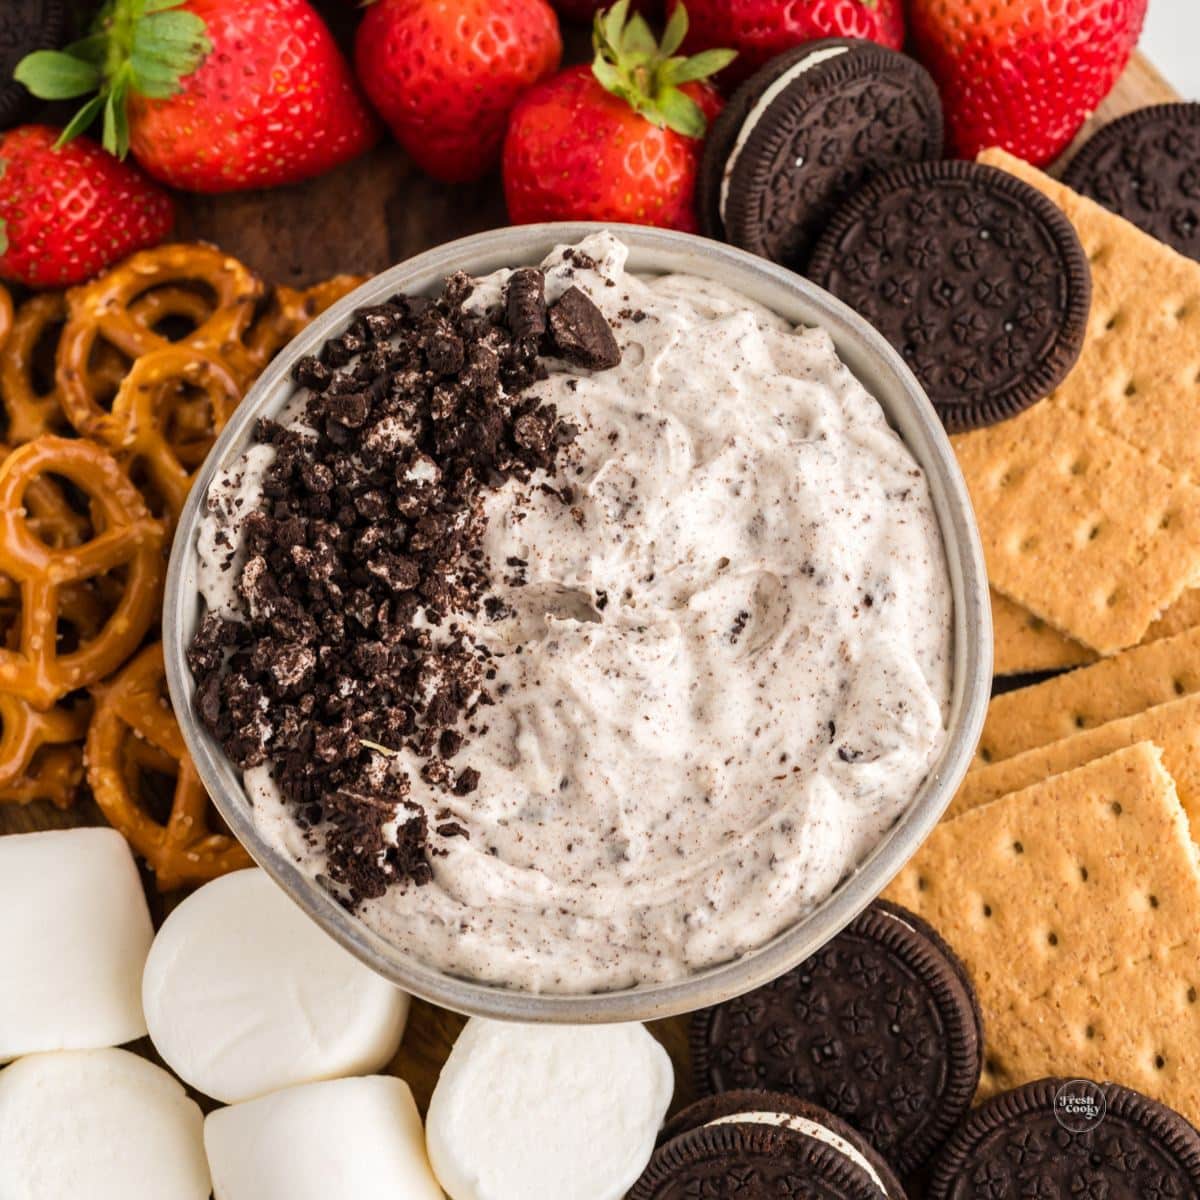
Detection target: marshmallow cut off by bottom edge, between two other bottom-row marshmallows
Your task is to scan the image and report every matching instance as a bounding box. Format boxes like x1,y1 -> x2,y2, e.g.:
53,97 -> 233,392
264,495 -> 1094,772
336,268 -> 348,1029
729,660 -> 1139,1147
204,1075 -> 443,1200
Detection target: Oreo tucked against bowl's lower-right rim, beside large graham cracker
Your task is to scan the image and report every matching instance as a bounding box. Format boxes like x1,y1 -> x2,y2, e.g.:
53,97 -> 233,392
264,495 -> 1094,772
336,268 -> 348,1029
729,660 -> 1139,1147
691,901 -> 983,1175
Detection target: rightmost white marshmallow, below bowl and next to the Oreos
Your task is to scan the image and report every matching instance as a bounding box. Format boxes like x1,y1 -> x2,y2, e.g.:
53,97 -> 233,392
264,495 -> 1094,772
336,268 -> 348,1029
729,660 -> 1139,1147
426,1018 -> 674,1200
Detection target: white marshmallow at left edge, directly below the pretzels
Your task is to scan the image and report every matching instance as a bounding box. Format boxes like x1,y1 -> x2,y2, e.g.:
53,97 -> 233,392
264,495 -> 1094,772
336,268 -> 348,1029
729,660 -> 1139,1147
0,829 -> 154,1062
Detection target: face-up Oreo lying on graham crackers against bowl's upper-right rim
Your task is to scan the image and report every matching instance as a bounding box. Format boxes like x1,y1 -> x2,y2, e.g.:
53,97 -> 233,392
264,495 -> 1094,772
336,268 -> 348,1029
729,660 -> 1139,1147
808,162 -> 1092,433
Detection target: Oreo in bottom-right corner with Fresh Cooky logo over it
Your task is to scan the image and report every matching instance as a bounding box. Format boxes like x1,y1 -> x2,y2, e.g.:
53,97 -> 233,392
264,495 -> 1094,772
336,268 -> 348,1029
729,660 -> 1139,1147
928,1079 -> 1200,1200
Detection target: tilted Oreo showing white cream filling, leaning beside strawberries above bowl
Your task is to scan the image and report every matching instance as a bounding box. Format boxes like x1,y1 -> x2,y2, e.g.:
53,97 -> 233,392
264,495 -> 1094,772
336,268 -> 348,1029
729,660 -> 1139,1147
697,38 -> 942,269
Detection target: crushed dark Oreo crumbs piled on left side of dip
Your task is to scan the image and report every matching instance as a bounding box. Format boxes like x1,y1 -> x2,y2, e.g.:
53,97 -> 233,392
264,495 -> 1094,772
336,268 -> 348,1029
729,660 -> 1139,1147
188,270 -> 620,910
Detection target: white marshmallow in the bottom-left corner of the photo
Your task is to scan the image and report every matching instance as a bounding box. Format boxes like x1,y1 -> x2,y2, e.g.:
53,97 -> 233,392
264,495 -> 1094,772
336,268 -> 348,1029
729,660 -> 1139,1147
0,1050 -> 210,1200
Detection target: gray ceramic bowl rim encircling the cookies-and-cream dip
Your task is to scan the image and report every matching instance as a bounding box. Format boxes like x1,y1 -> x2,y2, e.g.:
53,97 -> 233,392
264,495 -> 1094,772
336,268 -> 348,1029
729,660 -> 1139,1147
163,223 -> 991,1022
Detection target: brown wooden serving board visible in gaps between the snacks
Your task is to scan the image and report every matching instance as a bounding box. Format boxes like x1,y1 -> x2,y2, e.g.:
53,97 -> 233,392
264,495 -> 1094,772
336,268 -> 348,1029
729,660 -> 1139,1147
0,28 -> 1177,1128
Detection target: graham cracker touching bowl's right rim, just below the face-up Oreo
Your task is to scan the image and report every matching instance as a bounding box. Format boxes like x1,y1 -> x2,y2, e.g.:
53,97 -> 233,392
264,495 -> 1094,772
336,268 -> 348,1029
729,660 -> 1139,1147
954,398 -> 1200,654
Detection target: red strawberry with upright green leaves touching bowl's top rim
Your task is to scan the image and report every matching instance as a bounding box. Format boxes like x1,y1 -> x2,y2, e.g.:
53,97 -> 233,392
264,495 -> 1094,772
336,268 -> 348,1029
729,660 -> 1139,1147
504,0 -> 733,230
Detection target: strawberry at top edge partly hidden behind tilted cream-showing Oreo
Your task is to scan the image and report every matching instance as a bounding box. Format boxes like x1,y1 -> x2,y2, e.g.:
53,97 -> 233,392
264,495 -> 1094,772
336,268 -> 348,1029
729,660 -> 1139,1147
672,0 -> 902,79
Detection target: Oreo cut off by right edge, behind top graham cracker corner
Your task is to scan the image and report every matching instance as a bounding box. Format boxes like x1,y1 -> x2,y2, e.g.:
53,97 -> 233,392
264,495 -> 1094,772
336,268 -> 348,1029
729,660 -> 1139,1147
1062,103 -> 1200,260
